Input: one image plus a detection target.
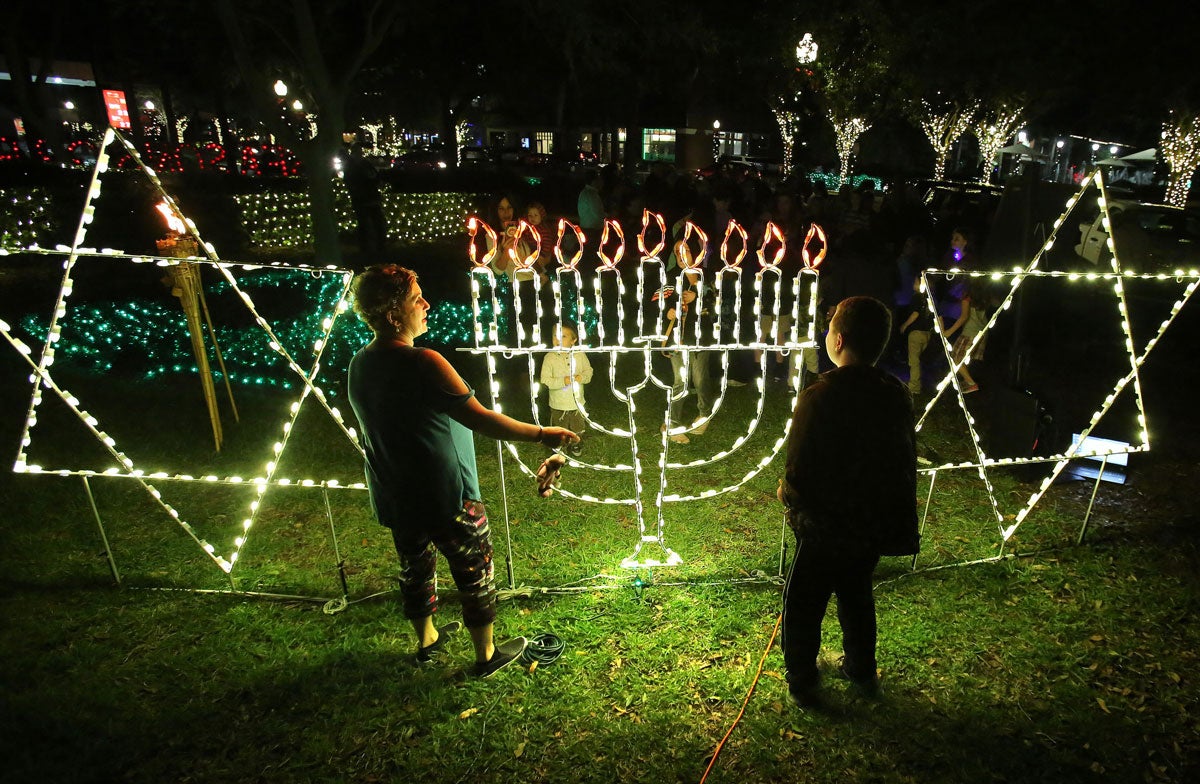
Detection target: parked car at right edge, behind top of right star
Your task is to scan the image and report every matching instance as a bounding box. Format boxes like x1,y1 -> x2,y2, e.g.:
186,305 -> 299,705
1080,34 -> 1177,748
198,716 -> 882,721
1075,199 -> 1200,273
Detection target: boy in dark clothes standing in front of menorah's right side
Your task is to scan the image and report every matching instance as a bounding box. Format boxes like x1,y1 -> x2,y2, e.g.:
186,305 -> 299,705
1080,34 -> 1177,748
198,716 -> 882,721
779,297 -> 919,707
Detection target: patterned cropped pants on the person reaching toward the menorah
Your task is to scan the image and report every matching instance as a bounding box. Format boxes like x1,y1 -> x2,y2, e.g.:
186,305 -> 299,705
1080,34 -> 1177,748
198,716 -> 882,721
391,501 -> 496,629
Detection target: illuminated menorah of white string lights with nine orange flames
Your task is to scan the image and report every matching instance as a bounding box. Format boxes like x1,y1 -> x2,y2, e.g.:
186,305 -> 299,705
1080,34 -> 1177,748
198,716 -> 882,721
464,210 -> 826,568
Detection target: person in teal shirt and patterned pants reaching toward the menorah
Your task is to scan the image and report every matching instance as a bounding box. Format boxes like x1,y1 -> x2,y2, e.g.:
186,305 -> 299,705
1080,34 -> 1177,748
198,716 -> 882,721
348,264 -> 577,677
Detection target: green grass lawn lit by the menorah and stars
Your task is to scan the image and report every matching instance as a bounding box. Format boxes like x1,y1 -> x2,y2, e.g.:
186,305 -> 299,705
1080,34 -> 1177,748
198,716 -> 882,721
0,267 -> 1200,783
